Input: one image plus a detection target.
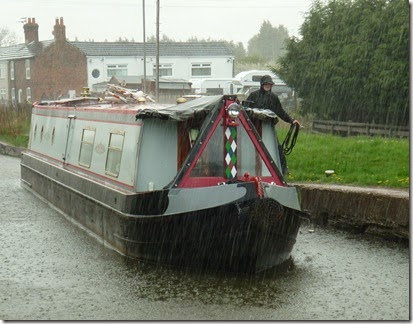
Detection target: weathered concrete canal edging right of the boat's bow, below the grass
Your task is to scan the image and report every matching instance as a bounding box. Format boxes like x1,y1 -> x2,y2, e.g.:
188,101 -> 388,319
295,183 -> 410,239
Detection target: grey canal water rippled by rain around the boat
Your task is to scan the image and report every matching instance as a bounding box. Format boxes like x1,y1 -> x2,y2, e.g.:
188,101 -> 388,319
0,155 -> 410,321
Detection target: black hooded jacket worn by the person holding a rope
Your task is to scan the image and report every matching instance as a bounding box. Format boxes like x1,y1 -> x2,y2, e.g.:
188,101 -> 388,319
247,75 -> 293,124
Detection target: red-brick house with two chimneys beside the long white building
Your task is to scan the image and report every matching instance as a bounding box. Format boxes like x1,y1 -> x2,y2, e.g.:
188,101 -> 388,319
0,18 -> 87,103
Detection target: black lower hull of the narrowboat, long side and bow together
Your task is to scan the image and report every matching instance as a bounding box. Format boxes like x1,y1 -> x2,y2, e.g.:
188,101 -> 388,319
21,157 -> 301,273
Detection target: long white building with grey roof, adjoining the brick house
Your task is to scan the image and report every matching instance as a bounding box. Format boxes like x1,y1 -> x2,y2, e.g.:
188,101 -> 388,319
70,42 -> 234,89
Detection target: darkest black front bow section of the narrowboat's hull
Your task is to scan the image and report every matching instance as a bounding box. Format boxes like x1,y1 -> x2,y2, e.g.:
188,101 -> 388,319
119,199 -> 301,273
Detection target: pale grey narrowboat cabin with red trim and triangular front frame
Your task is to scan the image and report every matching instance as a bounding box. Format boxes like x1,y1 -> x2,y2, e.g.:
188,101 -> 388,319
29,95 -> 285,193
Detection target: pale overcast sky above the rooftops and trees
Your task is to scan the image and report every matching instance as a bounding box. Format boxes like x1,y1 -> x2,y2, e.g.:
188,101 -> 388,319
0,0 -> 312,46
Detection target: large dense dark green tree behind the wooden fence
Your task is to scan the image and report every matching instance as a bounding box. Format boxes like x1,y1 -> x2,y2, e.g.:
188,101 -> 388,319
273,0 -> 409,125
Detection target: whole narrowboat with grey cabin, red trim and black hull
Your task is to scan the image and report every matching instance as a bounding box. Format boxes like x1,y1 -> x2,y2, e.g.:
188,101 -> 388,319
21,95 -> 306,273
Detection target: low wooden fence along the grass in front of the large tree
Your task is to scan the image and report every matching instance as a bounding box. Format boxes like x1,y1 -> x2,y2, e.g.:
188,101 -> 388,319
312,120 -> 410,138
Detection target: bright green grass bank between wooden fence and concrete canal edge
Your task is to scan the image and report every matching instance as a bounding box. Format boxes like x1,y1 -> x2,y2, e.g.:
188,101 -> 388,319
278,129 -> 410,188
